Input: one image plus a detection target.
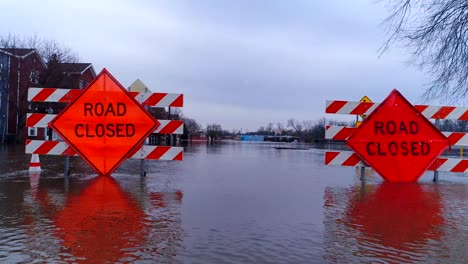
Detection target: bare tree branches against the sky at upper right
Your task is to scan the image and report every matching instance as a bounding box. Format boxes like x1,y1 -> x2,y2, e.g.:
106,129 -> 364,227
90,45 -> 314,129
379,0 -> 468,101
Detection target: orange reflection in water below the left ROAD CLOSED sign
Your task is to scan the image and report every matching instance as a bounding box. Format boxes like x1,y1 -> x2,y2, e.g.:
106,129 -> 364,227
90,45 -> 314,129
55,177 -> 147,263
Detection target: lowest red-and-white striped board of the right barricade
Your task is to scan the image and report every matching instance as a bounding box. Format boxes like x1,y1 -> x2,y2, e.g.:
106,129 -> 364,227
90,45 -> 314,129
325,151 -> 468,172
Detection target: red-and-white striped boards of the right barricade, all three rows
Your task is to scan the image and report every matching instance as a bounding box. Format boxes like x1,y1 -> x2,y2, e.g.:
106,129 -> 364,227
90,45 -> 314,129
325,100 -> 468,172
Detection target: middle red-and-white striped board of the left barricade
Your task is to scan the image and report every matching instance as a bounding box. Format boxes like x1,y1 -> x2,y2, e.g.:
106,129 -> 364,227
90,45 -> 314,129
26,113 -> 184,134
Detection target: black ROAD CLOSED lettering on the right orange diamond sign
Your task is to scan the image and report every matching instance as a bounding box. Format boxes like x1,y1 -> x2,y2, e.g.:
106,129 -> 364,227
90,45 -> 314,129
366,120 -> 431,156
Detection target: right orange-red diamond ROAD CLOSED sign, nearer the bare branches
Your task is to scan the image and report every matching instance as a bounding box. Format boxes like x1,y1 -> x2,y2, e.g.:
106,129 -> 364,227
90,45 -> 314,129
346,90 -> 449,182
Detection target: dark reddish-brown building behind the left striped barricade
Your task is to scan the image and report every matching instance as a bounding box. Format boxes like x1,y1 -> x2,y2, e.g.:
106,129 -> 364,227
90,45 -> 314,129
0,48 -> 96,144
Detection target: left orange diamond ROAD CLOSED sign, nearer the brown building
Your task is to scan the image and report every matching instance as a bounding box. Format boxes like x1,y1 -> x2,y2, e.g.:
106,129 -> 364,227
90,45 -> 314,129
50,69 -> 160,175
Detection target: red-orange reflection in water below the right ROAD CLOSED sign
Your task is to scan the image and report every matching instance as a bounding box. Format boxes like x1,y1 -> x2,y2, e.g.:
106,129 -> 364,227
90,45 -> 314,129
345,182 -> 444,253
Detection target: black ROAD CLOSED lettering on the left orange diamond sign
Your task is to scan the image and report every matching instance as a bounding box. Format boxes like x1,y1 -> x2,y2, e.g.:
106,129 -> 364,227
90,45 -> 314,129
75,103 -> 136,138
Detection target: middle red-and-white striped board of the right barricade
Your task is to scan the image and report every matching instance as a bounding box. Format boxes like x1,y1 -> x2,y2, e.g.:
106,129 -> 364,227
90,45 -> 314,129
325,126 -> 468,146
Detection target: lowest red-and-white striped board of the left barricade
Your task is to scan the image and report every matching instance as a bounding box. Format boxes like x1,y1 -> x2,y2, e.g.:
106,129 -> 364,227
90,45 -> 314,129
25,139 -> 184,160
